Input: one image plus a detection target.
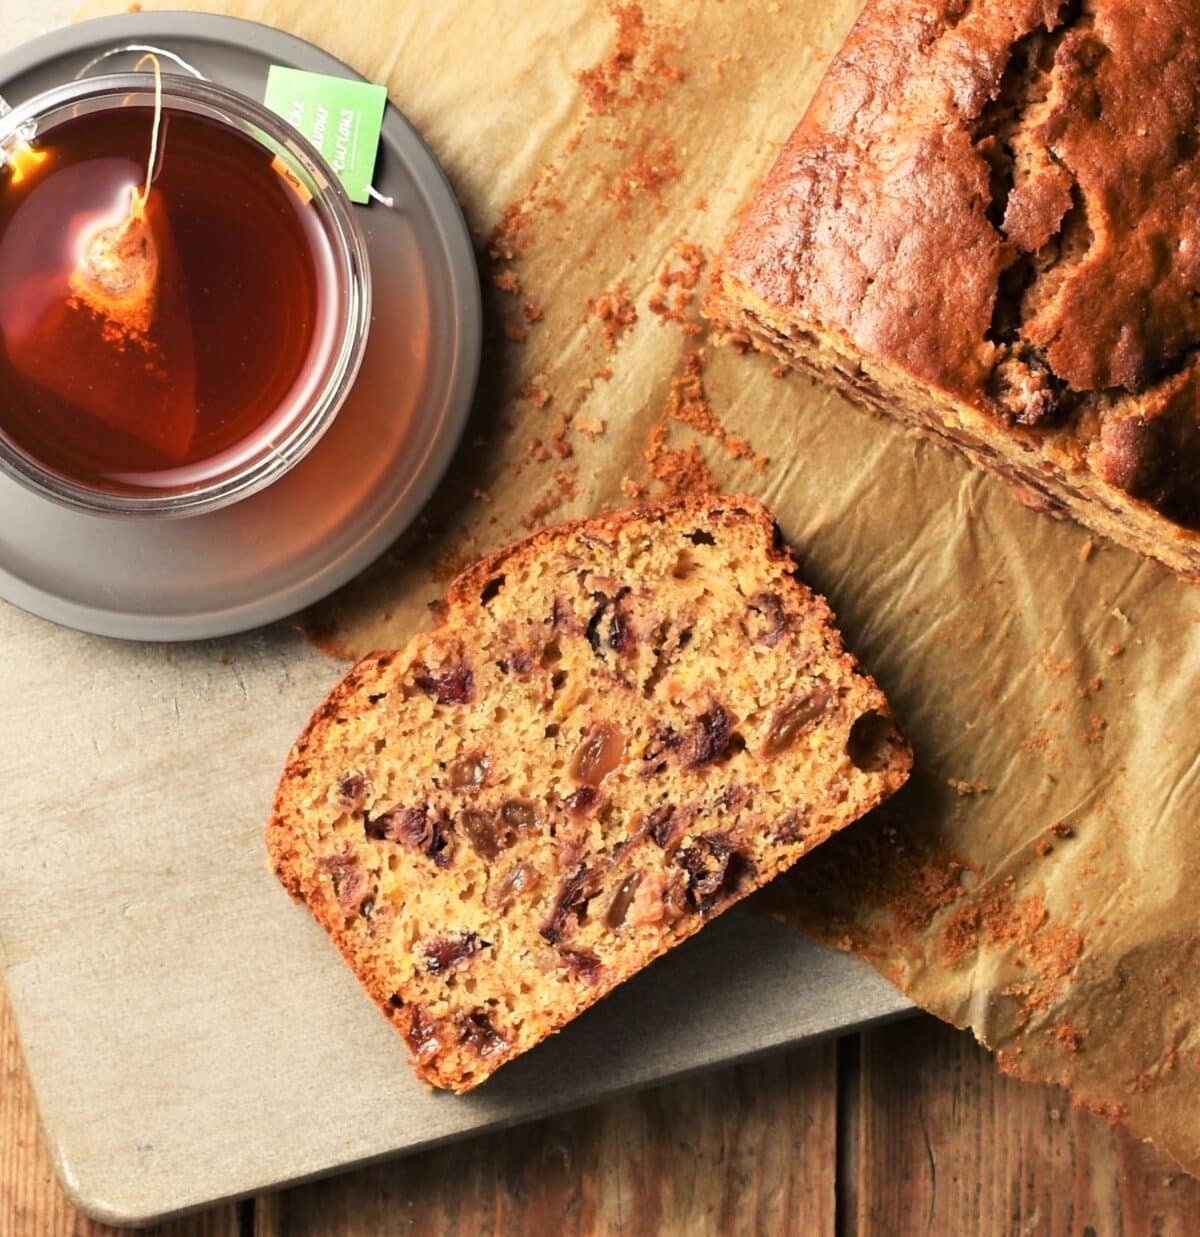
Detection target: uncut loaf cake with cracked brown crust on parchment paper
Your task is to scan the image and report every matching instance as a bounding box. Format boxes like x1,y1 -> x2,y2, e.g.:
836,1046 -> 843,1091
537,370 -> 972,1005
706,0 -> 1200,578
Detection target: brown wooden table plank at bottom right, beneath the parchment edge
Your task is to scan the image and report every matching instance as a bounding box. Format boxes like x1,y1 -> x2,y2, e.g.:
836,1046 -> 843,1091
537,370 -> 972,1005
856,1018 -> 1200,1237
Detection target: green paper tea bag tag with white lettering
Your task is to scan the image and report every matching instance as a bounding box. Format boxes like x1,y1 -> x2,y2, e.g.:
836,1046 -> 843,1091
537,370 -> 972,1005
262,64 -> 387,203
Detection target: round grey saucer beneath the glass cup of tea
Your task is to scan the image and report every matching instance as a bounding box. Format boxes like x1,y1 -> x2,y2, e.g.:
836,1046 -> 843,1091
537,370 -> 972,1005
0,12 -> 481,640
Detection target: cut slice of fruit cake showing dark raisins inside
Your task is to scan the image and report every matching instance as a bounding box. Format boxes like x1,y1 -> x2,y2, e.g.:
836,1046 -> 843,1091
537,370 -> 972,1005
267,499 -> 911,1091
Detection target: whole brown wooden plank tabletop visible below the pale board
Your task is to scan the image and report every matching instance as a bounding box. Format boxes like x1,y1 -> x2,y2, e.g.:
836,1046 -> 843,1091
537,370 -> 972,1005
0,989 -> 1200,1237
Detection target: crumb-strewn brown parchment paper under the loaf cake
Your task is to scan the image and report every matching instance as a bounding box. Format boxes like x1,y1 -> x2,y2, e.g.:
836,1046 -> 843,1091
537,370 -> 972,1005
89,0 -> 1200,1171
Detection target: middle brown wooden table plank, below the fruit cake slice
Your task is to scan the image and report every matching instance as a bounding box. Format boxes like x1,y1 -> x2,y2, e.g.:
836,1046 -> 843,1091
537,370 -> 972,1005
255,1043 -> 836,1237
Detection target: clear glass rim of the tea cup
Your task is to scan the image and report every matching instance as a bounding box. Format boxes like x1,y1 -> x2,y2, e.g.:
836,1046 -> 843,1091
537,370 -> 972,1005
0,72 -> 371,517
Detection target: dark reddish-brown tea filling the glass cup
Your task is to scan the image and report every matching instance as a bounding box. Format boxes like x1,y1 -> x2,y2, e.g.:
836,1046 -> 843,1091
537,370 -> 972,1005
0,105 -> 333,491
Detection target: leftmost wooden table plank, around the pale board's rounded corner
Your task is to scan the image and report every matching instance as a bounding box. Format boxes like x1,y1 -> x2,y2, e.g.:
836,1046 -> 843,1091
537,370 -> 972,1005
0,990 -> 238,1237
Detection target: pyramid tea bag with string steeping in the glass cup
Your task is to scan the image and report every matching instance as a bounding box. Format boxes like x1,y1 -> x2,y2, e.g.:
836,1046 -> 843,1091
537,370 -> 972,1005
0,57 -> 197,466
